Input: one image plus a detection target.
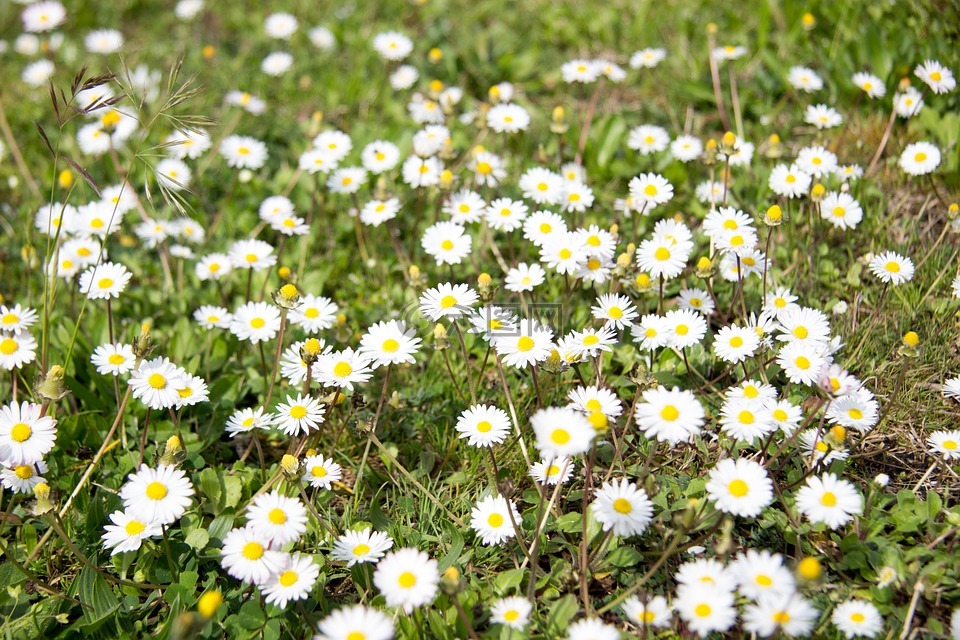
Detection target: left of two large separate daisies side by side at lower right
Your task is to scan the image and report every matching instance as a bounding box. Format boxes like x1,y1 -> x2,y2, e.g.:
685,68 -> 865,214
707,458 -> 773,518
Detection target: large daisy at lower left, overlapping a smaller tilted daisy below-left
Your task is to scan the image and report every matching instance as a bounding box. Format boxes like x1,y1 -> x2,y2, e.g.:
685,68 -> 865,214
120,464 -> 194,525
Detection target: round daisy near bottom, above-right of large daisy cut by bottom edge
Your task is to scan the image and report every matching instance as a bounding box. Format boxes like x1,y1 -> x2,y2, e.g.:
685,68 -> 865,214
373,548 -> 440,615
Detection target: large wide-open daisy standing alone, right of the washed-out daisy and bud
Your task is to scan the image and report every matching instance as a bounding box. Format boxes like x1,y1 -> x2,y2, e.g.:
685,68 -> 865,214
634,387 -> 705,446
